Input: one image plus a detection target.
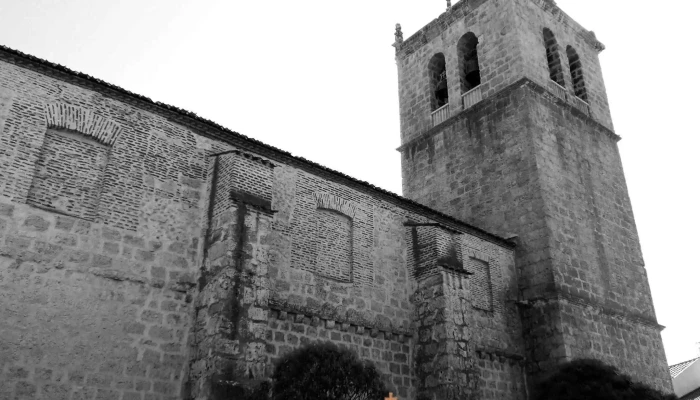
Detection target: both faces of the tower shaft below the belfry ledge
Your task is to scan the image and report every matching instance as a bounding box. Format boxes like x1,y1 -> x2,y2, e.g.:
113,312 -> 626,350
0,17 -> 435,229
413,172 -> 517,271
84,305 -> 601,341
401,79 -> 670,390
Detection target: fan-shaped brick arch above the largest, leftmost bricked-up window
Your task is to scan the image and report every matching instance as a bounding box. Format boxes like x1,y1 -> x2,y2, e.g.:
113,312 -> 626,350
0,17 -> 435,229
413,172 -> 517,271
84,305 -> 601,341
45,103 -> 122,146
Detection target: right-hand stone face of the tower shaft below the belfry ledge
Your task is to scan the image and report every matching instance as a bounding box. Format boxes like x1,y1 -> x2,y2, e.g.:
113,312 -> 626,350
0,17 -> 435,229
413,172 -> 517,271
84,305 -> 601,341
528,83 -> 670,390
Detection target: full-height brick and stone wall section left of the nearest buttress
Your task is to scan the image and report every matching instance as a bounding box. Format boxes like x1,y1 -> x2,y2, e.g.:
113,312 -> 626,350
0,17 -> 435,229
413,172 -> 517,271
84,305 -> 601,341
0,61 -> 213,400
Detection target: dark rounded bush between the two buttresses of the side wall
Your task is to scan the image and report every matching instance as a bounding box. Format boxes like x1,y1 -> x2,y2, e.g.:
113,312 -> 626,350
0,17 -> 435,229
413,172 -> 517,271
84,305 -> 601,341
272,343 -> 388,400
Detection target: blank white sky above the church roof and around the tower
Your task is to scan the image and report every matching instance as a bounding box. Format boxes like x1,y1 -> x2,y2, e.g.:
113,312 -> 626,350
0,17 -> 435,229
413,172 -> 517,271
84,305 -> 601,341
0,0 -> 700,364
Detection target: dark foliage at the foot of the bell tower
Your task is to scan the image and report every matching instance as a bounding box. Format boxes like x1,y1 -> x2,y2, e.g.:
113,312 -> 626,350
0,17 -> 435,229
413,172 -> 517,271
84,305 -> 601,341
535,359 -> 677,400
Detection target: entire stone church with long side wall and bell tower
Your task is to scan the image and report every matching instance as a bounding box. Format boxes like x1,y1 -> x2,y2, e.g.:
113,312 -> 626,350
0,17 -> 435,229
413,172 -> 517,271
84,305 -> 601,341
0,0 -> 673,400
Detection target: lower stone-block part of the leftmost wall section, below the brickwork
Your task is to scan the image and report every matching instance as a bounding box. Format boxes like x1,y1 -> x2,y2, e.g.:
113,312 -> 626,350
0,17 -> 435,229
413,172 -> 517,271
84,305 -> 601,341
0,197 -> 194,399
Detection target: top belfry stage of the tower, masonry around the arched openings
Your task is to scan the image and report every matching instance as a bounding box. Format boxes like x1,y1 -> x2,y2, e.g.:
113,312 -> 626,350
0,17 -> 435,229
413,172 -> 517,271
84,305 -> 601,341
395,0 -> 614,148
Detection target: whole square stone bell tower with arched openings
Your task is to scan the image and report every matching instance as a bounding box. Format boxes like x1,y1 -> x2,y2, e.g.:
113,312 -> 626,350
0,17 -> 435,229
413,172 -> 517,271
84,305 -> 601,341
394,0 -> 671,391
